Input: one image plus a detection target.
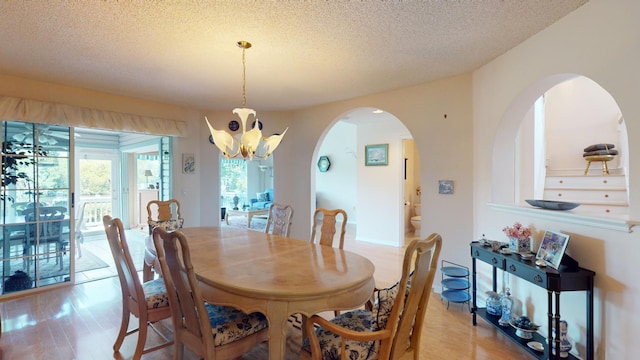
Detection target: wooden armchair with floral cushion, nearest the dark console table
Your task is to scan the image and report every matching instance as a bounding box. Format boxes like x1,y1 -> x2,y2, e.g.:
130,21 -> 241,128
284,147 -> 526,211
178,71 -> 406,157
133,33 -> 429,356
303,233 -> 442,360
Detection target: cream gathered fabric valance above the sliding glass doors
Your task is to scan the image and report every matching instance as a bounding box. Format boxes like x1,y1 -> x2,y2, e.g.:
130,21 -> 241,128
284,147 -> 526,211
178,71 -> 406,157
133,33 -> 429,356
0,96 -> 187,136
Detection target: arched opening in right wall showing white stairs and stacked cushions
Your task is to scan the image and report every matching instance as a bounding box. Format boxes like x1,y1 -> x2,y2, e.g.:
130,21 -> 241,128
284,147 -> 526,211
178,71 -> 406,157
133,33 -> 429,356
491,74 -> 629,218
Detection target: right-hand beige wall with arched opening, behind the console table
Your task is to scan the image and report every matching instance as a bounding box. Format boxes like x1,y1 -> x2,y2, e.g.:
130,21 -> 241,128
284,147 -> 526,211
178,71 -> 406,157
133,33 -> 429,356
473,0 -> 640,359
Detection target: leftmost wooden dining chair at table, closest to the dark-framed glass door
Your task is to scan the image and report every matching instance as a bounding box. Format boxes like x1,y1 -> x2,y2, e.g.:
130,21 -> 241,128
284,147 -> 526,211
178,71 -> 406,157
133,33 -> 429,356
103,215 -> 173,360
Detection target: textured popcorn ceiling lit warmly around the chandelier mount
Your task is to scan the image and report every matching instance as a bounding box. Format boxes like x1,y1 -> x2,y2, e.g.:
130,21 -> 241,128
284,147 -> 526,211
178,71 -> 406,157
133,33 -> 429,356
0,0 -> 587,111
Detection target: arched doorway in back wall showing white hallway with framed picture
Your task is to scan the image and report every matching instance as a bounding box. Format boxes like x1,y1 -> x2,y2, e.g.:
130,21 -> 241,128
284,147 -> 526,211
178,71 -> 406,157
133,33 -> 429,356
311,108 -> 420,246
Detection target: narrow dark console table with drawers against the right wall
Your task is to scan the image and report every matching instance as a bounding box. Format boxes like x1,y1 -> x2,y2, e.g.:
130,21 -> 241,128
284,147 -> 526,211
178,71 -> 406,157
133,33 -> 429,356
471,242 -> 596,360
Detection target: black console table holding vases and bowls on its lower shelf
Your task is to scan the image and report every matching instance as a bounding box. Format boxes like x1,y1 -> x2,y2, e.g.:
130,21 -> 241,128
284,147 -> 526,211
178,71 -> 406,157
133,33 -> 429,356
470,239 -> 595,360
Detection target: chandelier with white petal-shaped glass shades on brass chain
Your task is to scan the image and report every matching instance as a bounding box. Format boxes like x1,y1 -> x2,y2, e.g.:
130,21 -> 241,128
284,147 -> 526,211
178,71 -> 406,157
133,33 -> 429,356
204,41 -> 289,160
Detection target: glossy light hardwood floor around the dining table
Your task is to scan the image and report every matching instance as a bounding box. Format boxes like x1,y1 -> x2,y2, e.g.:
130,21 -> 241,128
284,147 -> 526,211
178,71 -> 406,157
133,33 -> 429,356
0,226 -> 532,360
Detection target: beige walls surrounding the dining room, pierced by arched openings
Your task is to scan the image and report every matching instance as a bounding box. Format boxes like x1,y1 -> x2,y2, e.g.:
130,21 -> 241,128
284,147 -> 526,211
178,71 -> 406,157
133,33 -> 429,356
0,0 -> 640,359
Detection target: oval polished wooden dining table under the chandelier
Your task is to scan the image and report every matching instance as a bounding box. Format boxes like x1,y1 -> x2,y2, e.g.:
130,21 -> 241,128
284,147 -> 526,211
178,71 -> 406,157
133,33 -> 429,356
172,227 -> 374,359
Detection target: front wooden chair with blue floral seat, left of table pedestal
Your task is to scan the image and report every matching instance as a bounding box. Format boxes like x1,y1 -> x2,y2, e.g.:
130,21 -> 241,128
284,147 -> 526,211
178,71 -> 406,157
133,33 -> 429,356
153,227 -> 268,359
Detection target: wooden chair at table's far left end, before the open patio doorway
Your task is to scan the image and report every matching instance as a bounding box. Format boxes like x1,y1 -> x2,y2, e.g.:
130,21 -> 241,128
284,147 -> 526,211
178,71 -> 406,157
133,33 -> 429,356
142,199 -> 184,281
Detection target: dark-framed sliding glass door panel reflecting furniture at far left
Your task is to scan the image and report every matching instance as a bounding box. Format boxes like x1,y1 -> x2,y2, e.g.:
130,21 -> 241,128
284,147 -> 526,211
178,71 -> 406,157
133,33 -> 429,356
0,121 -> 74,294
